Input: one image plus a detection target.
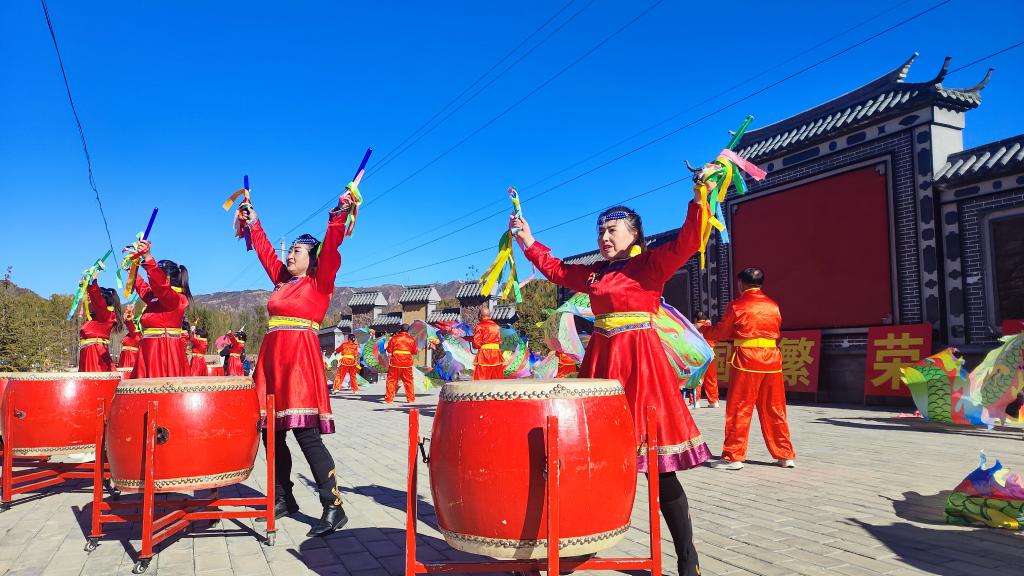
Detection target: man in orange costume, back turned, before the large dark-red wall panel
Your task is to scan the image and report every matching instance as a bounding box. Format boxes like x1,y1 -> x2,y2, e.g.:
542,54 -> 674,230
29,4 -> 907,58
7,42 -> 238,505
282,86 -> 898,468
701,268 -> 797,470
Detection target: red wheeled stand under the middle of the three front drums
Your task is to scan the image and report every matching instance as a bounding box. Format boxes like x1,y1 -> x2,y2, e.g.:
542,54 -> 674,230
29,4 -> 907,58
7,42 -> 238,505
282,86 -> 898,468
85,395 -> 278,574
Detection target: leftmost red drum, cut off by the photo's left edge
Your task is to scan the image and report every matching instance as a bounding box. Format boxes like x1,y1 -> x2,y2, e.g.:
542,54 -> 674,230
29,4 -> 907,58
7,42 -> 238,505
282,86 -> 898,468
0,372 -> 121,456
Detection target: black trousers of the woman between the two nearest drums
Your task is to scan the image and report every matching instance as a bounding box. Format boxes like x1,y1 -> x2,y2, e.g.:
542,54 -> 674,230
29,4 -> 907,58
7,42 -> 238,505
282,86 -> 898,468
263,428 -> 341,507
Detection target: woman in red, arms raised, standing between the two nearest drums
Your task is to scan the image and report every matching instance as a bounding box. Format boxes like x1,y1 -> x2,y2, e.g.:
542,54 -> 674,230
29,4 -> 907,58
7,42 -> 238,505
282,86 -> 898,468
242,188 -> 352,536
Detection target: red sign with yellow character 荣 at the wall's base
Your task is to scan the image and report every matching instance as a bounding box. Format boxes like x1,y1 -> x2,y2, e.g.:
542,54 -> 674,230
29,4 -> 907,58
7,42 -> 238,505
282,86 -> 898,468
864,324 -> 932,396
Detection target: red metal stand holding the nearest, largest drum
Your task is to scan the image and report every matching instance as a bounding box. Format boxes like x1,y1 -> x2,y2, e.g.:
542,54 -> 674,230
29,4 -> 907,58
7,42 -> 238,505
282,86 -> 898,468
406,407 -> 662,576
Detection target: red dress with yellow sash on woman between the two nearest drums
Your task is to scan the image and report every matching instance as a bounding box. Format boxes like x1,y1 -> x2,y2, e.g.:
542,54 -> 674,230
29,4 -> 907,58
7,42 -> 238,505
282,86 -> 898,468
249,211 -> 348,434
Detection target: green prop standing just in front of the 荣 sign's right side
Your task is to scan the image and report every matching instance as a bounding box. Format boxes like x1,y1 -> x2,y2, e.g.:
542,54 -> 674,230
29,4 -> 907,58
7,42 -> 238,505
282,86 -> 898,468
900,348 -> 986,425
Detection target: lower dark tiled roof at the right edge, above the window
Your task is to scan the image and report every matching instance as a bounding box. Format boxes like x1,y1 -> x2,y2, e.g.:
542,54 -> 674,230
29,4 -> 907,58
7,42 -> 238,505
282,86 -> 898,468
935,134 -> 1024,188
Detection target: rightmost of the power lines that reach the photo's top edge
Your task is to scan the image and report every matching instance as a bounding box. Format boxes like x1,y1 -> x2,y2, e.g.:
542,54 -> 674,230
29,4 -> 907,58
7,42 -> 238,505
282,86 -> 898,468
335,0 -> 951,280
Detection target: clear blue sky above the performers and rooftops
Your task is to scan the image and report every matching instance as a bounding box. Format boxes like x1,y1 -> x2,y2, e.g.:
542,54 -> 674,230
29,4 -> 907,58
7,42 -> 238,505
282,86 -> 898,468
0,0 -> 1024,295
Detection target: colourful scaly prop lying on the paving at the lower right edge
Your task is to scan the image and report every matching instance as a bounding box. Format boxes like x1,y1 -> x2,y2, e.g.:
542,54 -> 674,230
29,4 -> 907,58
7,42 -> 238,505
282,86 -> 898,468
945,452 -> 1024,530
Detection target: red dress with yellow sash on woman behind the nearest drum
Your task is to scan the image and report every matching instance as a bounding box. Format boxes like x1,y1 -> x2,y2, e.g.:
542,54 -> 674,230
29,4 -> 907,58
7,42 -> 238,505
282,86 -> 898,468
525,203 -> 711,472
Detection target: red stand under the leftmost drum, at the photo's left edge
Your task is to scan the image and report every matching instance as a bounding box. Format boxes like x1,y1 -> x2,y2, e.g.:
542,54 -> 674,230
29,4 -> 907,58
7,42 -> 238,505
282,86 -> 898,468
0,390 -> 111,511
